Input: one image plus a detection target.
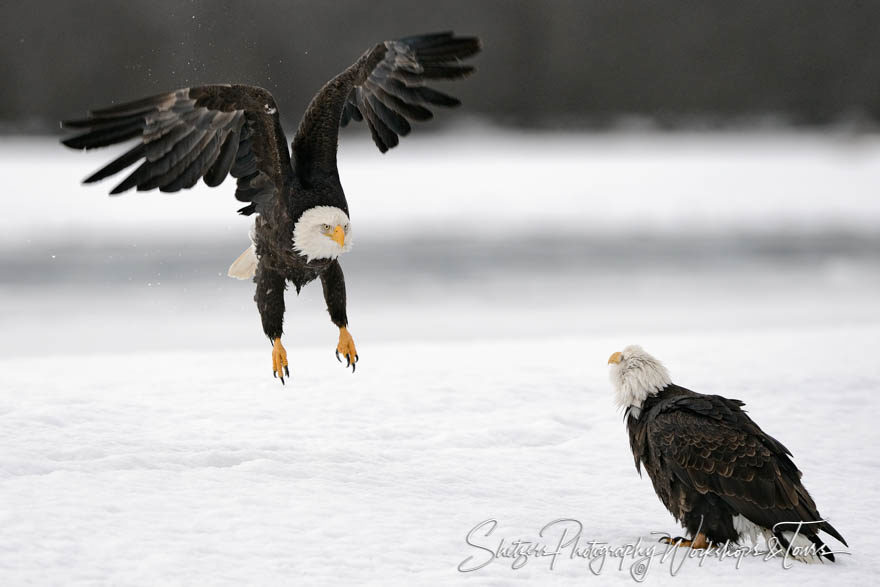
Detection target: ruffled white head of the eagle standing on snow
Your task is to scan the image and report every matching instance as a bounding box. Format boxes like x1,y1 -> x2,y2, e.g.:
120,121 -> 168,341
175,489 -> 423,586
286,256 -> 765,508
608,345 -> 672,416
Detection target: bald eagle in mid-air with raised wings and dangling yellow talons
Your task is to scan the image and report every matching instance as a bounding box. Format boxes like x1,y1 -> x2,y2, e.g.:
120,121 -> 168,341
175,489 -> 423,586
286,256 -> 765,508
62,32 -> 480,383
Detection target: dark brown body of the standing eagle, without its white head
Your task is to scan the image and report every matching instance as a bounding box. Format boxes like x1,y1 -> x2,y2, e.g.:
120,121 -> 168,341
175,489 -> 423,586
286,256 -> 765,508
626,384 -> 846,560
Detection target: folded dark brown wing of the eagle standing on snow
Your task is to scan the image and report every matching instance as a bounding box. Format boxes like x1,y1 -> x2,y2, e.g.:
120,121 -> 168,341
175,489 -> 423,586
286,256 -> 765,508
646,395 -> 846,544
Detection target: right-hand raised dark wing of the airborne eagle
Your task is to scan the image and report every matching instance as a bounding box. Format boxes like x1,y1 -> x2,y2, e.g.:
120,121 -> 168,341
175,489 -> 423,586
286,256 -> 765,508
293,32 -> 480,177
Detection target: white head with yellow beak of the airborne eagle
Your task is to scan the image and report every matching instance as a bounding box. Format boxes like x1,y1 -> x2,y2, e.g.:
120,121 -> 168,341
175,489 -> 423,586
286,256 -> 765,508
293,206 -> 353,261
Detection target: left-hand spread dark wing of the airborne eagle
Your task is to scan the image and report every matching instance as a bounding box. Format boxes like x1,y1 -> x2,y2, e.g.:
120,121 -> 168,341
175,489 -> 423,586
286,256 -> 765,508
62,85 -> 291,214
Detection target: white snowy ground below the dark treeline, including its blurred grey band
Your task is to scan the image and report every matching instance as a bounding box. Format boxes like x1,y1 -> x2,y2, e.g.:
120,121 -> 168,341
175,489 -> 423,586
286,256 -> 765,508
0,128 -> 880,585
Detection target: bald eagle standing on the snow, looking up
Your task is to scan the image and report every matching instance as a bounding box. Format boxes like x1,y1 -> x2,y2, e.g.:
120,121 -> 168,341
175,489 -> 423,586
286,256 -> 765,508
608,345 -> 846,562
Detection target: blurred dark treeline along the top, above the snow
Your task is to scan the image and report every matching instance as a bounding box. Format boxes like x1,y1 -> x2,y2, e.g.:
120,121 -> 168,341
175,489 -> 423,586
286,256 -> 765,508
0,0 -> 880,132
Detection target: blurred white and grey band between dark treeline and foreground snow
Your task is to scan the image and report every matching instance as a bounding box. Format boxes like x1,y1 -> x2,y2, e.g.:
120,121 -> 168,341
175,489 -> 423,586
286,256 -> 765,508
0,130 -> 880,358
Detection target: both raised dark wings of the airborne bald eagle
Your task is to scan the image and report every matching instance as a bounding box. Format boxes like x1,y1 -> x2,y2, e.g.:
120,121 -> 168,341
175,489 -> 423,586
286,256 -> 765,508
62,32 -> 480,214
